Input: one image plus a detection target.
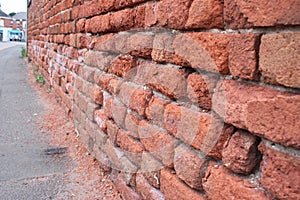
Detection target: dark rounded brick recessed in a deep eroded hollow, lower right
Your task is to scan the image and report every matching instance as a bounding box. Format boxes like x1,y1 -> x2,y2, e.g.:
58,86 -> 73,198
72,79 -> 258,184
222,130 -> 260,174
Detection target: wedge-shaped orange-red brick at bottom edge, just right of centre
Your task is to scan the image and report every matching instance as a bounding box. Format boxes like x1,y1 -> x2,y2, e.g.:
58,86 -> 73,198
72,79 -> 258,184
160,169 -> 205,200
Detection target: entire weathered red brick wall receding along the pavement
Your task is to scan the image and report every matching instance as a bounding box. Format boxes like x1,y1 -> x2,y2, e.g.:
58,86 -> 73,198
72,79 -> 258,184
28,0 -> 300,199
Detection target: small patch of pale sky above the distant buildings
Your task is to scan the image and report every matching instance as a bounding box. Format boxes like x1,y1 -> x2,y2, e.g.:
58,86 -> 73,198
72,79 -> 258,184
0,0 -> 27,14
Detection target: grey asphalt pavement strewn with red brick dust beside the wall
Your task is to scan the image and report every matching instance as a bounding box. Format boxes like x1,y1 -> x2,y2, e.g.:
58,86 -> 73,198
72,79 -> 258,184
0,43 -> 68,200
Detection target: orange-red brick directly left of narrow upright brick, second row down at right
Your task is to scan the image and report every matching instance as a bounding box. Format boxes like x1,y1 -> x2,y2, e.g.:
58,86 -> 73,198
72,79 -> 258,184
173,32 -> 230,74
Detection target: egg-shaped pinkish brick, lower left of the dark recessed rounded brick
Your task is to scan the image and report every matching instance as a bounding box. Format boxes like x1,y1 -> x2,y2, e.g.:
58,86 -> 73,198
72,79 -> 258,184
174,145 -> 207,190
